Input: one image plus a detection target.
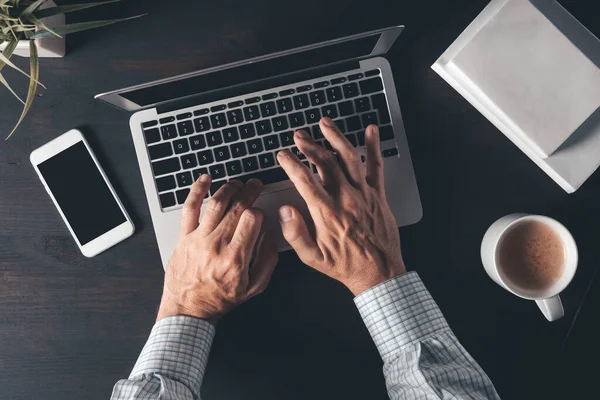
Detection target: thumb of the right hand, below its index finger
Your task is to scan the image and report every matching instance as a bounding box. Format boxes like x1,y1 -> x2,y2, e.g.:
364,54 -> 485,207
279,206 -> 322,266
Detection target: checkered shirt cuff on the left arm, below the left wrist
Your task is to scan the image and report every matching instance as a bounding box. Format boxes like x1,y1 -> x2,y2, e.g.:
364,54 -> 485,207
129,316 -> 215,394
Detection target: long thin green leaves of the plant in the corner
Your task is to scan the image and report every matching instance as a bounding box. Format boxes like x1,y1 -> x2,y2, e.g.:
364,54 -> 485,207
0,0 -> 142,139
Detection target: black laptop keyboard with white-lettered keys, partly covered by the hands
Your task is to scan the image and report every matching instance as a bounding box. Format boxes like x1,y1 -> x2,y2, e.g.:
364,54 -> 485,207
142,69 -> 398,210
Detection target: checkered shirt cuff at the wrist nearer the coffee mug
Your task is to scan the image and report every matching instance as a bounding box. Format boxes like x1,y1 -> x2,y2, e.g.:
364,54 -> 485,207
354,272 -> 450,362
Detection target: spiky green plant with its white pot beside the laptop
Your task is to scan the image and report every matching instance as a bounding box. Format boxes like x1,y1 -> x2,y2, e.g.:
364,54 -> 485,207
0,0 -> 140,139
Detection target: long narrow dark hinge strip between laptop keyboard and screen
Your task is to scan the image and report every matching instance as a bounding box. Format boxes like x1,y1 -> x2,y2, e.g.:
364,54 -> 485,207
156,60 -> 360,114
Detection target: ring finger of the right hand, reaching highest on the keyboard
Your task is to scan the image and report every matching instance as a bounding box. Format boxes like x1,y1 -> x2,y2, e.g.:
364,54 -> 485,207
319,117 -> 365,187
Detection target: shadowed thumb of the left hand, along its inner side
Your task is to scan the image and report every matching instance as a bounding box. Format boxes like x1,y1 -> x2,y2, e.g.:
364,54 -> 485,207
248,232 -> 279,298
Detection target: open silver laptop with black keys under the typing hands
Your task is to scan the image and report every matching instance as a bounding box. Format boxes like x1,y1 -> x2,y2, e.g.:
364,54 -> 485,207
96,26 -> 422,267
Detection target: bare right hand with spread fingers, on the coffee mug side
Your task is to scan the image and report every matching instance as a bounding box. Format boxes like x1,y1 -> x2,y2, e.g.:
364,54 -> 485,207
277,118 -> 406,296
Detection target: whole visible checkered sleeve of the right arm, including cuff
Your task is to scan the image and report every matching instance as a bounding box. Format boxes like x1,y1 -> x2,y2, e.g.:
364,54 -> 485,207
354,272 -> 499,400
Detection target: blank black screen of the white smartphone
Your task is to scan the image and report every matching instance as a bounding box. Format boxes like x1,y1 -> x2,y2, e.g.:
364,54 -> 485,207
38,142 -> 127,246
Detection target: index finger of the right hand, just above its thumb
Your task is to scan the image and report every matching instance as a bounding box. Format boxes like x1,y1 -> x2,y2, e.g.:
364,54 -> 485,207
277,150 -> 329,207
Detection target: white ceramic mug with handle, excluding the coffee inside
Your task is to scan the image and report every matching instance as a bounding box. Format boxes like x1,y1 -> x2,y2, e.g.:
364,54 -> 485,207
481,214 -> 578,321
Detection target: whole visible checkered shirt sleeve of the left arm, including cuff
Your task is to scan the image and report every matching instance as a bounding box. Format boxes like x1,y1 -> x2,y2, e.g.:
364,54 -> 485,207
111,316 -> 215,400
